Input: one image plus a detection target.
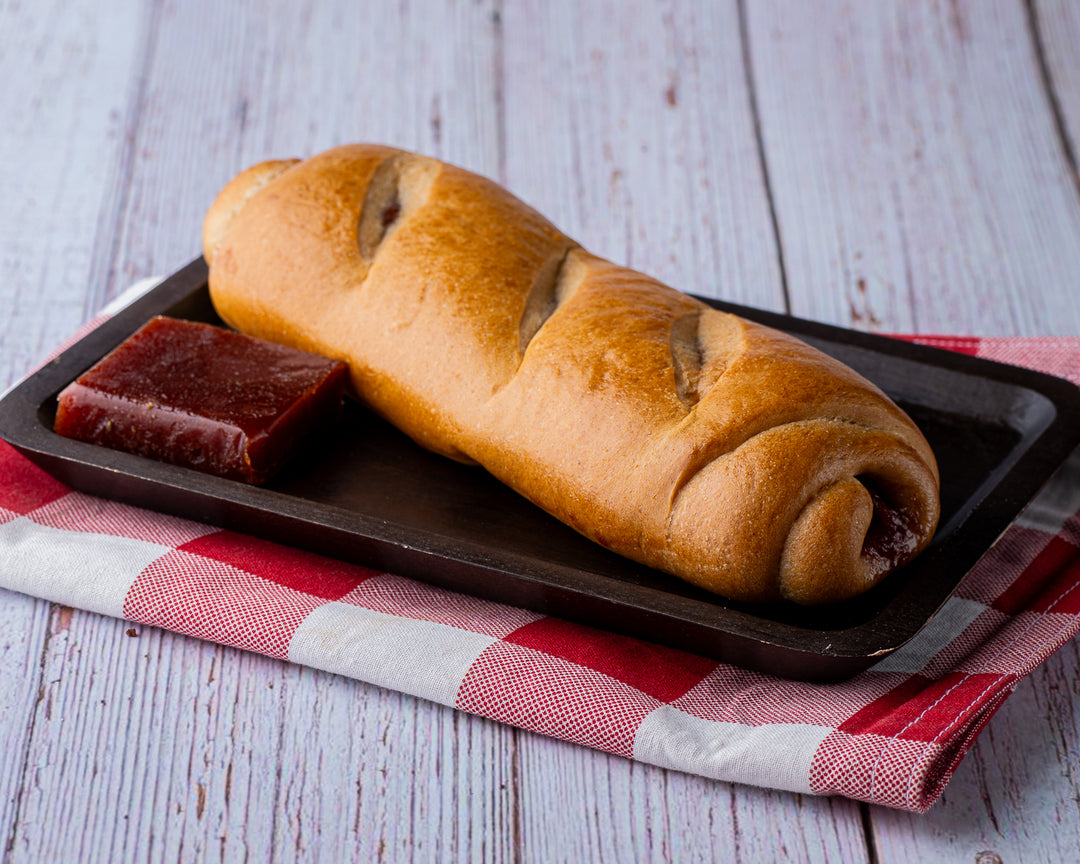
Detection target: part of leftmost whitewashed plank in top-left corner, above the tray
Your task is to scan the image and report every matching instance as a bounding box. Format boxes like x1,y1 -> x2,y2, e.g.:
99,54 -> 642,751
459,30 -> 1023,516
0,2 -> 143,389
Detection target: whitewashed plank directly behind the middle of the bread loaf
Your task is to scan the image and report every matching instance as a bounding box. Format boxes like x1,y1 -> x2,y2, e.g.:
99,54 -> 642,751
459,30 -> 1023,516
501,0 -> 784,309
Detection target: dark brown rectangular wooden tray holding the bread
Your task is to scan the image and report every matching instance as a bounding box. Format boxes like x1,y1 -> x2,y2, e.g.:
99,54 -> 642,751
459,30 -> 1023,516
0,258 -> 1080,680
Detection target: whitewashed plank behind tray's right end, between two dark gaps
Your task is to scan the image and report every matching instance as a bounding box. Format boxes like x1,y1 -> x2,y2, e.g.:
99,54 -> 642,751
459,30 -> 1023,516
747,0 -> 1080,335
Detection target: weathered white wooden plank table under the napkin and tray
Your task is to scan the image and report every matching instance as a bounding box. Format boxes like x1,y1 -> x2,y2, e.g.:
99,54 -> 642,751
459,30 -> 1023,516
0,0 -> 1080,862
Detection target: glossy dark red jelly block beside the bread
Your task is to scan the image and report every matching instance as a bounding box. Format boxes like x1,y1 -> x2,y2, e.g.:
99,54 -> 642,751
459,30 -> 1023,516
54,316 -> 346,483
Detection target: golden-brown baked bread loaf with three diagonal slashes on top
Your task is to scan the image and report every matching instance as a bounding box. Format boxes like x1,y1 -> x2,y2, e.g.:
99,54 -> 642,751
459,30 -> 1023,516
203,145 -> 940,604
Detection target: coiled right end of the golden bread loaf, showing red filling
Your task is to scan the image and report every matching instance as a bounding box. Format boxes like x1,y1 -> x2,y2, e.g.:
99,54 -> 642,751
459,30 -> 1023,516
669,420 -> 940,606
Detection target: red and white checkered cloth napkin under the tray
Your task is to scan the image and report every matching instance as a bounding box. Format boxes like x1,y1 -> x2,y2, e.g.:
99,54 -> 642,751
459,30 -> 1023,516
0,295 -> 1080,811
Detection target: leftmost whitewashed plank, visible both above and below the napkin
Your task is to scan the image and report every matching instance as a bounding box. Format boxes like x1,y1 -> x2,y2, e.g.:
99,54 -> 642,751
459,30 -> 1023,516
0,2 -> 140,858
